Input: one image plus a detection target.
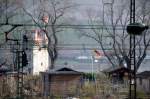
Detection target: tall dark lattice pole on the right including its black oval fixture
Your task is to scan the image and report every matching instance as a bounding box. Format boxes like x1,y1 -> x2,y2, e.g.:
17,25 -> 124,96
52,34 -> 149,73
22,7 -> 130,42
127,0 -> 148,99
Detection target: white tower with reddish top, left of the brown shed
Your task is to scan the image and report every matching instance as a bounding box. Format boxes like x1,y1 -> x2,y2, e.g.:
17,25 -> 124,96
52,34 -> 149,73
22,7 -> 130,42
32,30 -> 49,74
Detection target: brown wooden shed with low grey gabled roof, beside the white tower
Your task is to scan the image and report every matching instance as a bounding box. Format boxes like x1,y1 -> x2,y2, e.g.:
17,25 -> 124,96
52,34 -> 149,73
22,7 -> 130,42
41,67 -> 83,96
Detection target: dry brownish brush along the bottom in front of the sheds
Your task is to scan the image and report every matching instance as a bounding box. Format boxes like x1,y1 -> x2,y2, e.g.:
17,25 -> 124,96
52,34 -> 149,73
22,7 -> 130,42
0,75 -> 150,99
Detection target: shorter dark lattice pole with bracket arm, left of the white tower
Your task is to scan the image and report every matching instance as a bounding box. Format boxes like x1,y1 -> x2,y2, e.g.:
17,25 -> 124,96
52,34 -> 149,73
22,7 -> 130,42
6,35 -> 28,99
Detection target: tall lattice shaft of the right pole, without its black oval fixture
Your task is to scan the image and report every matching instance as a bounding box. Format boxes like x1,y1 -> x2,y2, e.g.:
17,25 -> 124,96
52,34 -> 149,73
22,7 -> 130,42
129,0 -> 136,99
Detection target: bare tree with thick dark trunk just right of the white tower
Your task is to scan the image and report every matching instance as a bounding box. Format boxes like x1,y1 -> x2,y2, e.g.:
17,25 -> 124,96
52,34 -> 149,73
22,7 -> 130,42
24,0 -> 74,69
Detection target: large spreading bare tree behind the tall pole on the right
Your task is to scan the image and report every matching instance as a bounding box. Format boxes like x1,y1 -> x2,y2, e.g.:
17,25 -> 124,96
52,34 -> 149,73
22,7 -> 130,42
83,0 -> 150,70
